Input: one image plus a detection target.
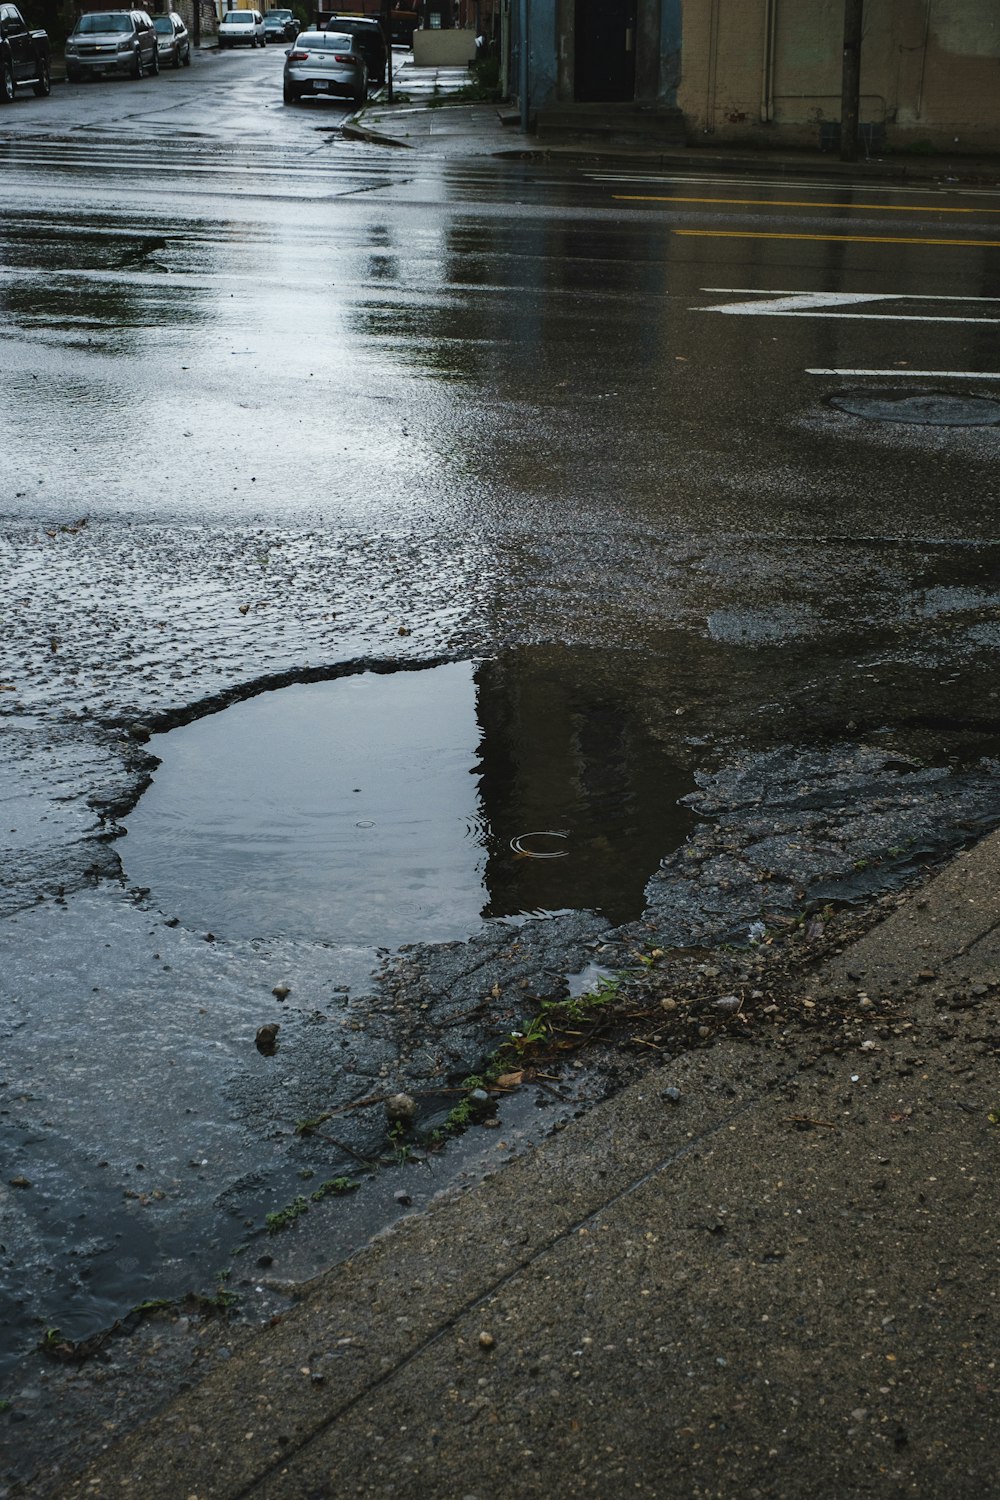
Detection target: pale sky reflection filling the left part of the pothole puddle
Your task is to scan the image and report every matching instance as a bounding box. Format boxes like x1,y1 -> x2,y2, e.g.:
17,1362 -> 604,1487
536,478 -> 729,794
123,663 -> 486,944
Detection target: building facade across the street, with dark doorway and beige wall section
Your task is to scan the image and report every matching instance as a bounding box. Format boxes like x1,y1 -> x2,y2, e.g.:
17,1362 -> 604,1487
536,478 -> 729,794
510,0 -> 1000,153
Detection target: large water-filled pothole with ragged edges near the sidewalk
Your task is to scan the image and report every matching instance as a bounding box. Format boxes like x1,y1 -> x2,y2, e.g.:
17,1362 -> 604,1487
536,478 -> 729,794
118,651 -> 693,947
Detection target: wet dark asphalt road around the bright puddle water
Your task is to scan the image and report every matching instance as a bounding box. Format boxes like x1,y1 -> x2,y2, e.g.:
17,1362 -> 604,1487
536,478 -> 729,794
0,50 -> 1000,1464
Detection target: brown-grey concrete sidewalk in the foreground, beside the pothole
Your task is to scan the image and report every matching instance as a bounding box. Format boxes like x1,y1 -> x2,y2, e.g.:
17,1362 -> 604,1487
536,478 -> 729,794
60,834 -> 1000,1500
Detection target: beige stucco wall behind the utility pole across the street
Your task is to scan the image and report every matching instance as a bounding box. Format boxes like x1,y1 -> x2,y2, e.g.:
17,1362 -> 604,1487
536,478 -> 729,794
678,0 -> 1000,152
